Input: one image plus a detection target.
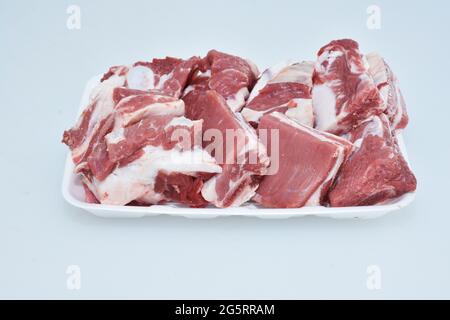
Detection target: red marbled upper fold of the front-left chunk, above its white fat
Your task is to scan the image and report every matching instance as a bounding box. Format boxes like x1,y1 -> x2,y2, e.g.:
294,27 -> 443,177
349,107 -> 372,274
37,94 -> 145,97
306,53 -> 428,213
77,94 -> 187,181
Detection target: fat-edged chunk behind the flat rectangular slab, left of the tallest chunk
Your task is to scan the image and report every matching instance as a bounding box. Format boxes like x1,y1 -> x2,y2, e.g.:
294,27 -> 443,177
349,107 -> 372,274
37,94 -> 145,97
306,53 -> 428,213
242,62 -> 314,127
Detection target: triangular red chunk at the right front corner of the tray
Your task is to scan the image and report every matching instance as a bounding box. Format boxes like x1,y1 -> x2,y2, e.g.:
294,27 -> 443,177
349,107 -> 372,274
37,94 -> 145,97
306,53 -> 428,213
329,114 -> 417,207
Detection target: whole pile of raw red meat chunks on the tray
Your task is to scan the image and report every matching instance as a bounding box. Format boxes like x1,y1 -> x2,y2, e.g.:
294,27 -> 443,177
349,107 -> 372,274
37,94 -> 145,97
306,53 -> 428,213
63,39 -> 416,208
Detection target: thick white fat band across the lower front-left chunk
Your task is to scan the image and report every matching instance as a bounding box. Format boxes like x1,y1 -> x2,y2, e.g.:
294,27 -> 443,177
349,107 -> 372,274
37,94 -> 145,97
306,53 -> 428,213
94,146 -> 222,205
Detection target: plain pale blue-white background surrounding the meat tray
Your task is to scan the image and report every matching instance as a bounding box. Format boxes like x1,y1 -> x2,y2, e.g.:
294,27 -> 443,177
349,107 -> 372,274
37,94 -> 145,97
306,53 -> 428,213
0,0 -> 450,299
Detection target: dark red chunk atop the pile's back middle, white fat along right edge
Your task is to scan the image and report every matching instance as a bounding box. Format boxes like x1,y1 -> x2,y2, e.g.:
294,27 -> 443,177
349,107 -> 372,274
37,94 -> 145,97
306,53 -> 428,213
184,50 -> 259,111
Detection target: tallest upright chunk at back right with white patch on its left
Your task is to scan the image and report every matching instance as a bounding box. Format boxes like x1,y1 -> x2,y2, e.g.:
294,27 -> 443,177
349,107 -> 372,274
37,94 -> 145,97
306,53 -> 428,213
312,39 -> 386,134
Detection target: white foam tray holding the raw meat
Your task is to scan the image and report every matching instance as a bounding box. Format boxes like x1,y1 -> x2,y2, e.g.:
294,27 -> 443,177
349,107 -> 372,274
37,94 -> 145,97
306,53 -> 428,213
62,76 -> 415,219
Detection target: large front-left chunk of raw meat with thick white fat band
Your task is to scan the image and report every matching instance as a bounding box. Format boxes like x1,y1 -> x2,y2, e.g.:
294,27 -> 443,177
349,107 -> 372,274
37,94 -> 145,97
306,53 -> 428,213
81,93 -> 222,207
